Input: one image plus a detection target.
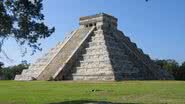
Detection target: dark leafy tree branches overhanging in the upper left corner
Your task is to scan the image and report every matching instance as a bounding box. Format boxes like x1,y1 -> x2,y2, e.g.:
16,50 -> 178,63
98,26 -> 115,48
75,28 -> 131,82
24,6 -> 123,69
0,0 -> 55,53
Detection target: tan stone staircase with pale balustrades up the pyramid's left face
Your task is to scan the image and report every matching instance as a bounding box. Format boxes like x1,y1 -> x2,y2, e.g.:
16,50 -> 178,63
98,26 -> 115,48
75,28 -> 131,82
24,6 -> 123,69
37,27 -> 94,80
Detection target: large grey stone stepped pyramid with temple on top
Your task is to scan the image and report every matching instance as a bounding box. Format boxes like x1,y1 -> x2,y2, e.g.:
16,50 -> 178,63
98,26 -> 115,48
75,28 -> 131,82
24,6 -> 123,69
15,13 -> 173,80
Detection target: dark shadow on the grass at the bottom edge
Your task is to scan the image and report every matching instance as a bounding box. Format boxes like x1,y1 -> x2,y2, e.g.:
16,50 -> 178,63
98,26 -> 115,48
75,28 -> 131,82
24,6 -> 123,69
49,100 -> 141,104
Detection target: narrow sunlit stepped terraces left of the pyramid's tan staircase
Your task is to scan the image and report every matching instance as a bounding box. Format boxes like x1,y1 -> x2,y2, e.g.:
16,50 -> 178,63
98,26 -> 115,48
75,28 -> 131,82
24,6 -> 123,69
15,30 -> 76,80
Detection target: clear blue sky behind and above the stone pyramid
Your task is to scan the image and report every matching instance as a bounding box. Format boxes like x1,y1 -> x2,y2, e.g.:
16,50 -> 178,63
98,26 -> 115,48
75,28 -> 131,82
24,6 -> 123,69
1,0 -> 185,65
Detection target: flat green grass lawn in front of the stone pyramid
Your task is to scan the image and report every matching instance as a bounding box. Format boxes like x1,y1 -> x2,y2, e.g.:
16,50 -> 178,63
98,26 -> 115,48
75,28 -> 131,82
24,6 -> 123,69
0,81 -> 185,104
